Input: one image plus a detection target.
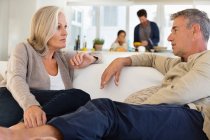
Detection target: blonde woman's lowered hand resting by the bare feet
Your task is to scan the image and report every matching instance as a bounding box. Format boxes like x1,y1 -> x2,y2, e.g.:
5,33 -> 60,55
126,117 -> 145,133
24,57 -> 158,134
23,105 -> 47,128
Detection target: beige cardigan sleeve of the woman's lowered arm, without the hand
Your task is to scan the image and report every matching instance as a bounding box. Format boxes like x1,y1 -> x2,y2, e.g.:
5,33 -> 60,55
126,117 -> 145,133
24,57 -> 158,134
6,43 -> 40,110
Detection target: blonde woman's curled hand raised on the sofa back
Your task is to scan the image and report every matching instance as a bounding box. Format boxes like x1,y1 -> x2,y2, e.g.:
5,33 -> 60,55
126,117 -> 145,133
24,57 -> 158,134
70,52 -> 96,68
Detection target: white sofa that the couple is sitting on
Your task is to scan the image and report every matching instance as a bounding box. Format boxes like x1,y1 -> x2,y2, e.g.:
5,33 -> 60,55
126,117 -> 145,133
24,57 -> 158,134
0,52 -> 163,101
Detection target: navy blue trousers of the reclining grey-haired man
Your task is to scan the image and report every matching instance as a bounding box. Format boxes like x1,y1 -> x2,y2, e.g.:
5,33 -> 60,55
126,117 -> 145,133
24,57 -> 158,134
49,99 -> 208,140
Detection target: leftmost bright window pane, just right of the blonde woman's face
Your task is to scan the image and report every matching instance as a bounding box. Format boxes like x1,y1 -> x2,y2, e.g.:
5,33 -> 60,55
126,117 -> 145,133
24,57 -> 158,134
68,6 -> 96,50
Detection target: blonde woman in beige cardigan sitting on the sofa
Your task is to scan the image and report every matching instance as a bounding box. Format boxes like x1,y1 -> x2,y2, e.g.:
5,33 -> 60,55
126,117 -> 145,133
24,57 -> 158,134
0,6 -> 100,128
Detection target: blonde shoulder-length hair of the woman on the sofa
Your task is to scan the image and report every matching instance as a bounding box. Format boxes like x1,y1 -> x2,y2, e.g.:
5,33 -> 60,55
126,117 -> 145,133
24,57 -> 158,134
28,6 -> 62,55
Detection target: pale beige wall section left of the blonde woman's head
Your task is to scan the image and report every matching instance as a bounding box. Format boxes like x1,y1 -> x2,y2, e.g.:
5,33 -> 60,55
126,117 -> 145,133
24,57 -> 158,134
8,0 -> 36,58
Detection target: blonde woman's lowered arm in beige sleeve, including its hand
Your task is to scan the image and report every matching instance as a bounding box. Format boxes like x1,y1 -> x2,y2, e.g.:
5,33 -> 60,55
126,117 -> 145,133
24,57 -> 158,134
6,43 -> 47,128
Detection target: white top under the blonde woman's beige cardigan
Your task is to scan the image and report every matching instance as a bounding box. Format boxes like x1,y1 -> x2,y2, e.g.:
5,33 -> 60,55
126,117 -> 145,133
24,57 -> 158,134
49,67 -> 65,90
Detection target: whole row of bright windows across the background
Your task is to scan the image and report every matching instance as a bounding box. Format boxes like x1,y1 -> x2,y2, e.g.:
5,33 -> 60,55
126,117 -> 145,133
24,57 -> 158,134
69,3 -> 210,50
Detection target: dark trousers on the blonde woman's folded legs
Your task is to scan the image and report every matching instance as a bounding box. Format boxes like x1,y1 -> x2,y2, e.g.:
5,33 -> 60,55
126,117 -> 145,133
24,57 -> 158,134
0,87 -> 90,127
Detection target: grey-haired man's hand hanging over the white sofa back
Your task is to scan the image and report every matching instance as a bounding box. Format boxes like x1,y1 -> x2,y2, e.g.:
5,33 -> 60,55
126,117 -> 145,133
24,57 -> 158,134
101,57 -> 131,89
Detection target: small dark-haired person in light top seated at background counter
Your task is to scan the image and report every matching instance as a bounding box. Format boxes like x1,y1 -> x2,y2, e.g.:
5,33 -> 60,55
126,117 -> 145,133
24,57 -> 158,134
110,30 -> 128,52
